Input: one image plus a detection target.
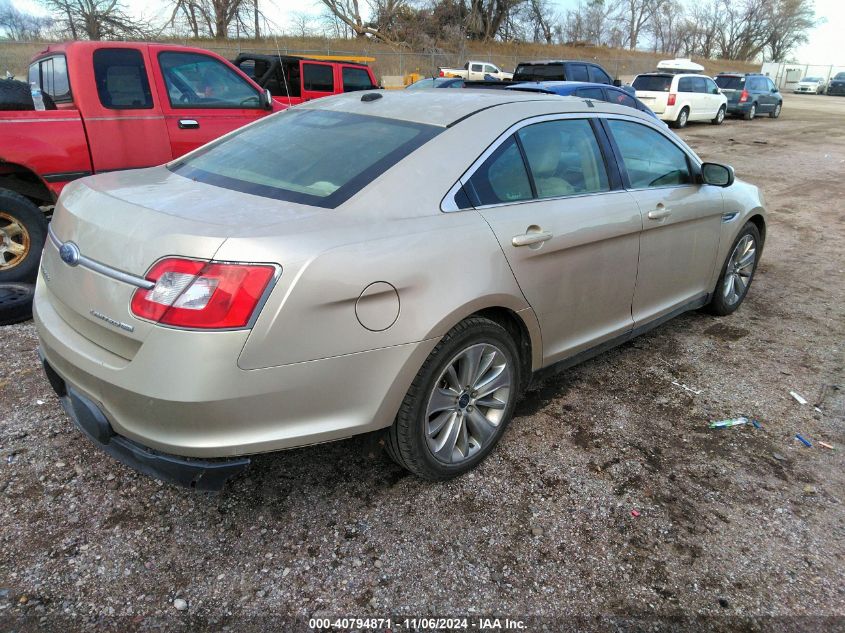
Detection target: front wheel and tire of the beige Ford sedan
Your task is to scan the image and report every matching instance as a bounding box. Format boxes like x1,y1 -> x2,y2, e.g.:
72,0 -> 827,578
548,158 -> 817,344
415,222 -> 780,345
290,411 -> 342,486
706,222 -> 762,316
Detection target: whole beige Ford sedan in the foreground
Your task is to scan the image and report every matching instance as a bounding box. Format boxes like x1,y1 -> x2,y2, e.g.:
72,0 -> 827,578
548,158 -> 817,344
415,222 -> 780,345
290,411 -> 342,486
34,90 -> 766,489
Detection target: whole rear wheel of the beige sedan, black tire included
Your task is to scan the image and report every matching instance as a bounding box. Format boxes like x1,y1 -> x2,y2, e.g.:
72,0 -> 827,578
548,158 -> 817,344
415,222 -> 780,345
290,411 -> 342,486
386,317 -> 521,481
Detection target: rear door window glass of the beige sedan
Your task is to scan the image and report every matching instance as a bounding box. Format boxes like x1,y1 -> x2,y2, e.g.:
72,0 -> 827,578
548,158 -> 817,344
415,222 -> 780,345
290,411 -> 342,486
517,119 -> 609,198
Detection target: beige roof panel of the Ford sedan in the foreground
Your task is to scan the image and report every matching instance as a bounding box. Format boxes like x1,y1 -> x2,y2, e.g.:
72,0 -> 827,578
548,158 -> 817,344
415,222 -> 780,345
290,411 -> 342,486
293,89 -> 652,127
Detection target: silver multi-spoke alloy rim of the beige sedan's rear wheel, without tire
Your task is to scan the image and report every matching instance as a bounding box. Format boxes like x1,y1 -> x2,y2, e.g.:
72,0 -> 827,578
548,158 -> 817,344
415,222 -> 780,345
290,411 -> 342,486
425,343 -> 515,465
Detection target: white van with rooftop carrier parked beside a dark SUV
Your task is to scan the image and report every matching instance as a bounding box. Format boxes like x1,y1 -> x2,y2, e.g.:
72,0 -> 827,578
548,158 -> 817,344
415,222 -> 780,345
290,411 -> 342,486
632,73 -> 728,127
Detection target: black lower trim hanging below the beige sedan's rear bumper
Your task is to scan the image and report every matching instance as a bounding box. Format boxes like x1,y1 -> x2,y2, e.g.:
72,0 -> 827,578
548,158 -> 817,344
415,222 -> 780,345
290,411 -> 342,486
39,349 -> 250,490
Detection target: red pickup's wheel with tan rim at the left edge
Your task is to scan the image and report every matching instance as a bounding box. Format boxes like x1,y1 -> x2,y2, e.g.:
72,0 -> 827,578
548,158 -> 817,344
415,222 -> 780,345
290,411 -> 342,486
0,190 -> 47,283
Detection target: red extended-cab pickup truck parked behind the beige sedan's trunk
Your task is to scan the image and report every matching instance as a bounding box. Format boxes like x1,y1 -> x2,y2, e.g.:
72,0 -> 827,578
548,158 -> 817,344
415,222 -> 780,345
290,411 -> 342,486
0,42 -> 286,282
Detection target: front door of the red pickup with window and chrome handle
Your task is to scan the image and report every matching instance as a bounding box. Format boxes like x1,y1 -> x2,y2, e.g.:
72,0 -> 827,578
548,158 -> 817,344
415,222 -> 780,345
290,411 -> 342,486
150,46 -> 269,158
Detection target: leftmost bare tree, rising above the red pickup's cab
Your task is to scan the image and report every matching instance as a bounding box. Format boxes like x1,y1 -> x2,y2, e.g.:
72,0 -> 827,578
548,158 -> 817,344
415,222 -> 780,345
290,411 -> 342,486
41,0 -> 147,40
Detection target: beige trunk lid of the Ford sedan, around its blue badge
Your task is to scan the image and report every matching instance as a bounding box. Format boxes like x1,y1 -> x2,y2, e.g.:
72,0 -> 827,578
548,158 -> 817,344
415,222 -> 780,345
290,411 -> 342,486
42,167 -> 322,360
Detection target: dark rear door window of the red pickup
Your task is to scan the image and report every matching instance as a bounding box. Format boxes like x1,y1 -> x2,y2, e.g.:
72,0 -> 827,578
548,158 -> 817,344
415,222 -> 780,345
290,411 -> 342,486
94,48 -> 153,110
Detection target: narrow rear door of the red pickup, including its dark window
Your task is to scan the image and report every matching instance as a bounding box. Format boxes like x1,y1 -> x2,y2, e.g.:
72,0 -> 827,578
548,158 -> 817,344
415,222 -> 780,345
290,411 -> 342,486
84,45 -> 172,172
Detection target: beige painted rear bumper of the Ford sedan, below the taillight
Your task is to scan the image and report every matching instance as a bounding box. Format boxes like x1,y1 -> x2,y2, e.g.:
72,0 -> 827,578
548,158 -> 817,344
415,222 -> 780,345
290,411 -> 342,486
33,280 -> 437,461
